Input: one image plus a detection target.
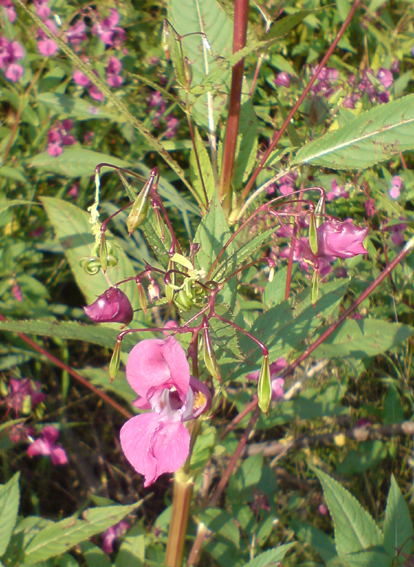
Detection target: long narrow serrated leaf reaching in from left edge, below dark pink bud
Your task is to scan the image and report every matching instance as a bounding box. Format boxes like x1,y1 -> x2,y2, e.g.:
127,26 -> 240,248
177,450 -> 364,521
0,319 -> 136,352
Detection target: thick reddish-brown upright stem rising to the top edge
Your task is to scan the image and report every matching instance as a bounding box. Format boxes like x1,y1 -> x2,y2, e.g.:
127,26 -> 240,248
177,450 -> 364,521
219,0 -> 249,216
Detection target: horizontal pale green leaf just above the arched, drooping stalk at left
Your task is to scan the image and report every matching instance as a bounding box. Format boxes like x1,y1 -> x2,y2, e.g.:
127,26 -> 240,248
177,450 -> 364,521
29,150 -> 130,179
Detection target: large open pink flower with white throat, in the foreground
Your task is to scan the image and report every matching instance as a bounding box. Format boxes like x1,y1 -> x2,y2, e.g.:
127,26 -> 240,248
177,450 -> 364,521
120,337 -> 211,487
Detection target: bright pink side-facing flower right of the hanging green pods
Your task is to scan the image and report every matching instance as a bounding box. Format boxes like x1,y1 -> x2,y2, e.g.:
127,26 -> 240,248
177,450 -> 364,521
317,219 -> 368,258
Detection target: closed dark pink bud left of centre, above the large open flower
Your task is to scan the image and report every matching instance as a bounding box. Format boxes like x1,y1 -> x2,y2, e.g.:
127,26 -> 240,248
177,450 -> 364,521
83,287 -> 134,325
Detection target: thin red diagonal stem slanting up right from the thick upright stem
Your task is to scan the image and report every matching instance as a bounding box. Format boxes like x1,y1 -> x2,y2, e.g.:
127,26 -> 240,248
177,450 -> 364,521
241,0 -> 361,201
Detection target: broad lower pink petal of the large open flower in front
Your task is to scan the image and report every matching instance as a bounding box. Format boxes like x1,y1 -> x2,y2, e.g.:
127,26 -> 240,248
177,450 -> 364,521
120,412 -> 190,487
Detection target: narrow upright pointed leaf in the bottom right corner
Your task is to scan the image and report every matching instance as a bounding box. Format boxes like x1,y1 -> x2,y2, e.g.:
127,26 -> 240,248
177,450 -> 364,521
384,475 -> 414,563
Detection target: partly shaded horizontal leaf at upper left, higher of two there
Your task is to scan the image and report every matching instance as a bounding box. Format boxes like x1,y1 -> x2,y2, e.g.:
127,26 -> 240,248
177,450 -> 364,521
37,93 -> 125,122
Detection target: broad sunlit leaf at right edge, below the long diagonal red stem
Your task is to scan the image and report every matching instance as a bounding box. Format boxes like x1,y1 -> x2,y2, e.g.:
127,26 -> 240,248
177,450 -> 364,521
314,319 -> 414,358
